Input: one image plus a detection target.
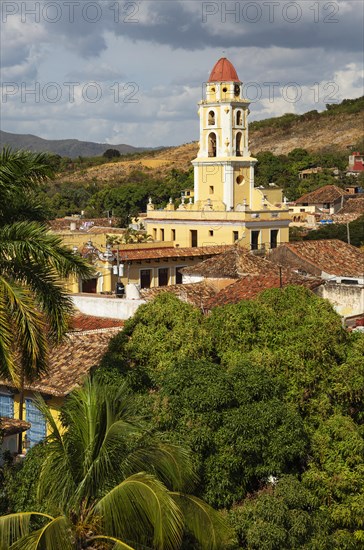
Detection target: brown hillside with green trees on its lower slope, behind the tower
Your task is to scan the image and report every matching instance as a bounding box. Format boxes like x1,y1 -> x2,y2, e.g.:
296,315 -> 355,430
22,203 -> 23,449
12,98 -> 364,227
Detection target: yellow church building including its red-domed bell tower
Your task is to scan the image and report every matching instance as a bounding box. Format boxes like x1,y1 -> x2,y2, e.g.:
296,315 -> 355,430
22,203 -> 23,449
143,58 -> 290,250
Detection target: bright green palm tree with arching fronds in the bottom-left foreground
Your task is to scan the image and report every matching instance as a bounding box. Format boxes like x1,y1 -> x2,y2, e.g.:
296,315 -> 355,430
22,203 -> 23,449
0,380 -> 228,550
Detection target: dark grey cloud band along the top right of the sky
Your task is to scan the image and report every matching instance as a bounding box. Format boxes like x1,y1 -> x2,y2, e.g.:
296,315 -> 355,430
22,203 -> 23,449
109,0 -> 363,51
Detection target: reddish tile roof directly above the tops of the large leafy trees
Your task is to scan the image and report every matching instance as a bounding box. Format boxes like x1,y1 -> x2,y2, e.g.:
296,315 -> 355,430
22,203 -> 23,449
206,270 -> 322,310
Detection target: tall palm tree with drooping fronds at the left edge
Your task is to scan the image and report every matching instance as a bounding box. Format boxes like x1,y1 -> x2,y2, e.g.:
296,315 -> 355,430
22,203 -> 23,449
0,149 -> 93,450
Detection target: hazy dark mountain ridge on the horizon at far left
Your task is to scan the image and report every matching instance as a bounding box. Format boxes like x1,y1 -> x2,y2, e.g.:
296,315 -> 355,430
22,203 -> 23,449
0,130 -> 150,158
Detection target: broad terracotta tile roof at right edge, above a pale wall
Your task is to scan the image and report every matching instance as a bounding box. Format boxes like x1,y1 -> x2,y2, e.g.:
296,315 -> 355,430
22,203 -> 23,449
282,239 -> 364,277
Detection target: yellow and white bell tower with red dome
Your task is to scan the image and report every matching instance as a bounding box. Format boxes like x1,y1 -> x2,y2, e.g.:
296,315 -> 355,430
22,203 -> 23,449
192,57 -> 257,211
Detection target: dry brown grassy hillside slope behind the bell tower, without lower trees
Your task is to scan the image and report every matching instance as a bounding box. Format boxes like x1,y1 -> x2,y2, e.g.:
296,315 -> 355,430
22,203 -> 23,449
52,96 -> 364,183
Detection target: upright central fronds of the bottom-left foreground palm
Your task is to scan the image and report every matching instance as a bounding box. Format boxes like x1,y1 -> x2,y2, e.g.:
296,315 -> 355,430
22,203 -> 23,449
36,379 -> 139,512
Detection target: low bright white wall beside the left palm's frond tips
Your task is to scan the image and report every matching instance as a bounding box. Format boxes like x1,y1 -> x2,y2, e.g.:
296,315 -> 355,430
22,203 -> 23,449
71,294 -> 145,320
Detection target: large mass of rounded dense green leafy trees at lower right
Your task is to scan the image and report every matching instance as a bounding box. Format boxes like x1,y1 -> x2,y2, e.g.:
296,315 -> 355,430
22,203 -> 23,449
98,287 -> 364,550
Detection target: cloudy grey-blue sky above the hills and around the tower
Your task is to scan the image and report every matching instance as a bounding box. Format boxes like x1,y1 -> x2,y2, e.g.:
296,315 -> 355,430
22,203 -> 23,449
0,0 -> 364,147
